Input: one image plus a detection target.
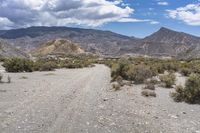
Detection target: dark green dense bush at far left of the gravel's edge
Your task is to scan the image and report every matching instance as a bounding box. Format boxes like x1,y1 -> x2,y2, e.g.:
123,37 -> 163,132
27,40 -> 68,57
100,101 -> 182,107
3,58 -> 33,72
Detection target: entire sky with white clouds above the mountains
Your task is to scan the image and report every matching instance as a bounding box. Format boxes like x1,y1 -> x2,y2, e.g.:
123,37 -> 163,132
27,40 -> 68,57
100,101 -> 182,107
0,0 -> 200,38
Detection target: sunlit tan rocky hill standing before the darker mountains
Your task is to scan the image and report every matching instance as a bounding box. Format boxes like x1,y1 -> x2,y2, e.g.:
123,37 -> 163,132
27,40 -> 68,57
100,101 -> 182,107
31,39 -> 85,56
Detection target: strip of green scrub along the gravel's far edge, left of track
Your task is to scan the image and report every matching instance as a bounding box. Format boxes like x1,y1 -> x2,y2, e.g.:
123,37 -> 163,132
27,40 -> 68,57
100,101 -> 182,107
3,56 -> 95,72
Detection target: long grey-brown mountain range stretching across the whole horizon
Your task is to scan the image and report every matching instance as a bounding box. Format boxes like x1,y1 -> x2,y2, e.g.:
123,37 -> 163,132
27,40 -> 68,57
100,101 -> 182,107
0,27 -> 200,58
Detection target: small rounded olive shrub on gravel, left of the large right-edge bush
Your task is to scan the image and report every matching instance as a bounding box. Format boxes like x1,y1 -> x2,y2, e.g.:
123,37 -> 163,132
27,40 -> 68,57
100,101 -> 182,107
159,73 -> 176,88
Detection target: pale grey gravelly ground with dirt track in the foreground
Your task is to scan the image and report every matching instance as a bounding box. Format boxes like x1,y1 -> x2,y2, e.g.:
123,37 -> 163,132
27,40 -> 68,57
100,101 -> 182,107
0,65 -> 200,133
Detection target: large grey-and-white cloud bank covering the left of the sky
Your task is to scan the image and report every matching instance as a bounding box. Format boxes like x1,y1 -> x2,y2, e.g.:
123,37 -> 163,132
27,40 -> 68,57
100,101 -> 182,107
0,0 -> 155,27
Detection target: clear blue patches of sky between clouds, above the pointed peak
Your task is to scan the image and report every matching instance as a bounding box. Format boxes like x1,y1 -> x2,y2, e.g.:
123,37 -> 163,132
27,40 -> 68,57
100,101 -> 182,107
100,0 -> 200,37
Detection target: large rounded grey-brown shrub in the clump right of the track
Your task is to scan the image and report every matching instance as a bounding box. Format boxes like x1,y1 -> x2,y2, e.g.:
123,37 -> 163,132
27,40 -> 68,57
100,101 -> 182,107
127,64 -> 154,84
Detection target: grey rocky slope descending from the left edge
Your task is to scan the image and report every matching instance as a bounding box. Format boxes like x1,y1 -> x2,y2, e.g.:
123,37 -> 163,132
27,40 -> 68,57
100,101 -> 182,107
0,39 -> 28,58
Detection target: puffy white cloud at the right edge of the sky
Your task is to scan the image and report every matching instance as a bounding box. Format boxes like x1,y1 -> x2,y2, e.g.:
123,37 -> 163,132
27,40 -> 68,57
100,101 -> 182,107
167,3 -> 200,26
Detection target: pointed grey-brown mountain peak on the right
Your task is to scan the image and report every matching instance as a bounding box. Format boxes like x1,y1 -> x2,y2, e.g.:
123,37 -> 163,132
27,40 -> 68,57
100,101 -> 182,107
134,28 -> 200,56
